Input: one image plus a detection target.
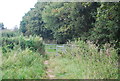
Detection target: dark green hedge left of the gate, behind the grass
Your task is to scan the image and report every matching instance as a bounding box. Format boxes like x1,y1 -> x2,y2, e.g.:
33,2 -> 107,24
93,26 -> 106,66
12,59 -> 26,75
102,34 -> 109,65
1,35 -> 45,54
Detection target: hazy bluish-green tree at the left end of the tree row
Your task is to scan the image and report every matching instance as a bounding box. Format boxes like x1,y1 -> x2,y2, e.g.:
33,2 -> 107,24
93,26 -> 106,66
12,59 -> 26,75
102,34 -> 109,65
20,2 -> 52,39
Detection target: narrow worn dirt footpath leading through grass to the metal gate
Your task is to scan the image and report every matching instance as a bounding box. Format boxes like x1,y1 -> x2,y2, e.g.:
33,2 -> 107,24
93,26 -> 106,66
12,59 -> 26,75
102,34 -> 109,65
44,44 -> 64,79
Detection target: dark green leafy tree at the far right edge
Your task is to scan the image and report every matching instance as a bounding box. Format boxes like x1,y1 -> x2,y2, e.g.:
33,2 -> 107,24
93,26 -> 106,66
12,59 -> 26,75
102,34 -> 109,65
89,3 -> 120,52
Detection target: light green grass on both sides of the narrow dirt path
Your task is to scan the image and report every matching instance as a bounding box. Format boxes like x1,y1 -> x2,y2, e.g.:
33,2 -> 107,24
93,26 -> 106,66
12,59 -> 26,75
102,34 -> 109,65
0,33 -> 118,79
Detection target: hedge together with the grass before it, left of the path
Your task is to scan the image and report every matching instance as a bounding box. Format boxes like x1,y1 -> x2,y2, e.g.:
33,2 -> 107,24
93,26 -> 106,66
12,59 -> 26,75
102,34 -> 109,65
0,30 -> 46,79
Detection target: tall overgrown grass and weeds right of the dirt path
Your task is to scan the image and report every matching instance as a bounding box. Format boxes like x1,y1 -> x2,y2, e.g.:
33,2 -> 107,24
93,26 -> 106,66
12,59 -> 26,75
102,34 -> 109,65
49,41 -> 118,79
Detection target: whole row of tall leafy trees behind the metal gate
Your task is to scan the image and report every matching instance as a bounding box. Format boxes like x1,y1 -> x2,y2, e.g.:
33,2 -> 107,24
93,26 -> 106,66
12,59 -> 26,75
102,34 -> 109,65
20,2 -> 120,53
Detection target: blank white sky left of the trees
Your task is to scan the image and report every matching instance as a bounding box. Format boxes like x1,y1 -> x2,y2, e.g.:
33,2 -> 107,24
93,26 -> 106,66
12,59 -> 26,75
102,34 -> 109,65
0,0 -> 37,29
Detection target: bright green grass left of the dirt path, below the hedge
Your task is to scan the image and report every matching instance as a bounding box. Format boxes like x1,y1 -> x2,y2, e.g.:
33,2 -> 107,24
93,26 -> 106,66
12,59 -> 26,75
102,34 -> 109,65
0,48 -> 45,79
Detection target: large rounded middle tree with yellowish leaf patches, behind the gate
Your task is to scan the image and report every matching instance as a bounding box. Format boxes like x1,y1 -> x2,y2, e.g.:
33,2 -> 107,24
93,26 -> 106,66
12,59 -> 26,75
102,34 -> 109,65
42,2 -> 97,43
